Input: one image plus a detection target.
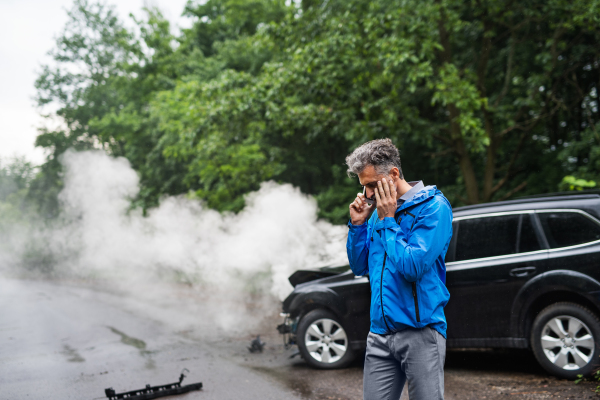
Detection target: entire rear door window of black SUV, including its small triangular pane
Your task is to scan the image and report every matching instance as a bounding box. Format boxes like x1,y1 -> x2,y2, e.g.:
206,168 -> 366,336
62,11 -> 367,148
455,214 -> 541,261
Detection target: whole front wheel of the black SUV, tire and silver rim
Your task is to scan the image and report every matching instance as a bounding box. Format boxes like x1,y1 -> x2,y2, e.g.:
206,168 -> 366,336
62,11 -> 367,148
296,310 -> 354,369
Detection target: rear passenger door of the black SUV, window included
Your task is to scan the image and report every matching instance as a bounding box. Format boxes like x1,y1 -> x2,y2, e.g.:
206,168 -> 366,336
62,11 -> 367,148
445,211 -> 548,339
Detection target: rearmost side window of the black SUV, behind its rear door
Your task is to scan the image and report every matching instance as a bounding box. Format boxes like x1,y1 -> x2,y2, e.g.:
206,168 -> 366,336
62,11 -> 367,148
538,212 -> 600,249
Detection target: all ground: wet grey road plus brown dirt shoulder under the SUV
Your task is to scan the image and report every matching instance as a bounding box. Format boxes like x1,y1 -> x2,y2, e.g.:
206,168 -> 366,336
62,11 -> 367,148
0,279 -> 596,400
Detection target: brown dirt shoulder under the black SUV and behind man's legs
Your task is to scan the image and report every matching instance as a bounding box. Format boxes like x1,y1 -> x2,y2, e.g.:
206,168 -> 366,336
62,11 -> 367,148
237,318 -> 598,400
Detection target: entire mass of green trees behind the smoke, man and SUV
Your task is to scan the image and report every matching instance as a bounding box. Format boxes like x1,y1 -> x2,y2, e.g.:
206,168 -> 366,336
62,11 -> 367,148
30,0 -> 600,223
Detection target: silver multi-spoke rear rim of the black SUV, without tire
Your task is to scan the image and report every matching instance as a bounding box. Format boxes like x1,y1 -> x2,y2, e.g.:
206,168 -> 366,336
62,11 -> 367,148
541,315 -> 595,371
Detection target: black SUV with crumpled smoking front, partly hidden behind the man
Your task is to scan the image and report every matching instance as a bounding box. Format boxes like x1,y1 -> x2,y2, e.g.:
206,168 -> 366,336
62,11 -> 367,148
278,194 -> 600,379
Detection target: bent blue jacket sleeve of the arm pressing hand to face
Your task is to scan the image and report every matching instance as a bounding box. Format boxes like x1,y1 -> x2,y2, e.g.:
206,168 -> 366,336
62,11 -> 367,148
374,199 -> 452,282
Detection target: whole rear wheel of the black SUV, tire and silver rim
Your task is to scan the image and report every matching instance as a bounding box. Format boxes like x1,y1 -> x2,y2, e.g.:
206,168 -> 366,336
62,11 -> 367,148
531,303 -> 600,379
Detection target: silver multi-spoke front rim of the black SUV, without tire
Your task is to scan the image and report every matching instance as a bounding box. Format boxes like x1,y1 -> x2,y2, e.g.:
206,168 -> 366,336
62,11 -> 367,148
304,318 -> 348,364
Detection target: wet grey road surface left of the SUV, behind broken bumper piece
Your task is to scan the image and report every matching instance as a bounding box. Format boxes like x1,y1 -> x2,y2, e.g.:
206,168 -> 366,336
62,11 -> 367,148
0,280 -> 300,400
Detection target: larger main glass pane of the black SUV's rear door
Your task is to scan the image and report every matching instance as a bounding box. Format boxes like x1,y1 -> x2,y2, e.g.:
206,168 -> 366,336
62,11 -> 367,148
455,214 -> 520,261
